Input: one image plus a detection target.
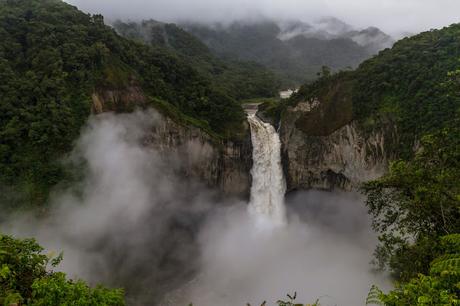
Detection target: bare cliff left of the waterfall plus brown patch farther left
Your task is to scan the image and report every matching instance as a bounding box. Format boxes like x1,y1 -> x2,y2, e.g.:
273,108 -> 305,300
92,84 -> 252,199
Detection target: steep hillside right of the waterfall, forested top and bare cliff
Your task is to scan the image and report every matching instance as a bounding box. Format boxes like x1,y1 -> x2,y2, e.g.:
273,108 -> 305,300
281,24 -> 460,189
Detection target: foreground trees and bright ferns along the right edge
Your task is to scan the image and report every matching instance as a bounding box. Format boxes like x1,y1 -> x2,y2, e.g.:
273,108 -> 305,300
363,49 -> 460,305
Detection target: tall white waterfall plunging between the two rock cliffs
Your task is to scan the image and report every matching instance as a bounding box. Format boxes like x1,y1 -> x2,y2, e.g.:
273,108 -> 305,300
248,110 -> 286,225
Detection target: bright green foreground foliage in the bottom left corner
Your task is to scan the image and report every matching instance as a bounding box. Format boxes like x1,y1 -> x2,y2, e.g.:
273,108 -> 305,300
0,235 -> 125,306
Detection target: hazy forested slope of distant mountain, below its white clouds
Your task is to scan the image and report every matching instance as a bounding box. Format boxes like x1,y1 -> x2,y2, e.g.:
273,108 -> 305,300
185,21 -> 372,87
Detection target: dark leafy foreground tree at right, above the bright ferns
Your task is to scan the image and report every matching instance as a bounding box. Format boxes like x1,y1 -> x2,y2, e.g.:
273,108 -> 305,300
363,121 -> 460,280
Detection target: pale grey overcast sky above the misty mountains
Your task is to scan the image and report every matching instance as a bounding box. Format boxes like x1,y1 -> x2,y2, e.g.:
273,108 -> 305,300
67,0 -> 460,35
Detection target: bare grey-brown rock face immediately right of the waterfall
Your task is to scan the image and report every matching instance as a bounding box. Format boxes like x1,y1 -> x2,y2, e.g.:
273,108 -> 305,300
280,100 -> 396,190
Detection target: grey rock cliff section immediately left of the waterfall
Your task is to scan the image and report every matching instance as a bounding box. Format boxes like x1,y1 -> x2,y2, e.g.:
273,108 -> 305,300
146,117 -> 252,199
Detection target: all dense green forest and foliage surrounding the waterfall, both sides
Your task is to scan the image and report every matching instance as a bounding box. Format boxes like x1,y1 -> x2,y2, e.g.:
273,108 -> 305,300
0,0 -> 460,306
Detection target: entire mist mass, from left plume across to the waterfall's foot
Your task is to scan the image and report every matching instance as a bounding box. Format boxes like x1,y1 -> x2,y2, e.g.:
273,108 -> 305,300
0,111 -> 387,306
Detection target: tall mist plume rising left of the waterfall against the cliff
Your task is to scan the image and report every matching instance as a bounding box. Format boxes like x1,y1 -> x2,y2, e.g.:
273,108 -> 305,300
0,111 -> 224,305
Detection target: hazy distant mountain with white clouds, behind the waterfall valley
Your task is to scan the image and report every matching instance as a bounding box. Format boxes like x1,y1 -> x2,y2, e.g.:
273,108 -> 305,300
181,18 -> 394,86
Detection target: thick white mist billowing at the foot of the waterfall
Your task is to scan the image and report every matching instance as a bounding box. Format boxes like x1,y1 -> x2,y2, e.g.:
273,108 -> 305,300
167,191 -> 389,306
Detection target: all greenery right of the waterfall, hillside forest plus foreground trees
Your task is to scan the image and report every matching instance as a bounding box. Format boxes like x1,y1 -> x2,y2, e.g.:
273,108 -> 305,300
289,24 -> 460,305
